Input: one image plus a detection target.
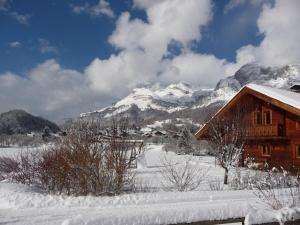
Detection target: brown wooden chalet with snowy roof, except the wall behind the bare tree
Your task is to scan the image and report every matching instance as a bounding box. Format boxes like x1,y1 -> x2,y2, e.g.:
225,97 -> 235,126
196,84 -> 300,170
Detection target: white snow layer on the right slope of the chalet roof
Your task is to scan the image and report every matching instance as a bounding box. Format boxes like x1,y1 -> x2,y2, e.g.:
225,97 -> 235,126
246,84 -> 300,109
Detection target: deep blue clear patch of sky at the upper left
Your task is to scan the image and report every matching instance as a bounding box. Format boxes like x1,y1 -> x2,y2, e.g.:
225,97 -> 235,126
0,0 -> 119,73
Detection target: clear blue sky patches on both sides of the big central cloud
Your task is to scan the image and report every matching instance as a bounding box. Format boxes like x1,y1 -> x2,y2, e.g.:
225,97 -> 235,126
0,0 -> 262,74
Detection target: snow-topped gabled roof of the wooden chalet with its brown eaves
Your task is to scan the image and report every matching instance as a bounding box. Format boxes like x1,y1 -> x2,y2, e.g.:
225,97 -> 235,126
196,84 -> 300,139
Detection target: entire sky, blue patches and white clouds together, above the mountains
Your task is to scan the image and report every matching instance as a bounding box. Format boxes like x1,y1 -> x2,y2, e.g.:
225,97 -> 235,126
0,0 -> 300,121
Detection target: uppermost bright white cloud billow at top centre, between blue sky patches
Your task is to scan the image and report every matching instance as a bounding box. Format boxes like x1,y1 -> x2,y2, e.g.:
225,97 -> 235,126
109,0 -> 212,58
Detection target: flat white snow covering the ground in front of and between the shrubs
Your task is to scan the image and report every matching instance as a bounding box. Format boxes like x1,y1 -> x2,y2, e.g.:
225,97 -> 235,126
0,145 -> 296,225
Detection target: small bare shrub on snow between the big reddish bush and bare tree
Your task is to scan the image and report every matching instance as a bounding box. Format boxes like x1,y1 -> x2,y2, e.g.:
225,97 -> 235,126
160,157 -> 207,191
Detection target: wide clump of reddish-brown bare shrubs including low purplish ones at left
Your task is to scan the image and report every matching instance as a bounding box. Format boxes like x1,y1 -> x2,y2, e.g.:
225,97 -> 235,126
0,118 -> 142,195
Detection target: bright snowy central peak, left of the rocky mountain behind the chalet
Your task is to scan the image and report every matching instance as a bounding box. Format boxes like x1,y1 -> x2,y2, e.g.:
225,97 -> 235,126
81,83 -> 213,117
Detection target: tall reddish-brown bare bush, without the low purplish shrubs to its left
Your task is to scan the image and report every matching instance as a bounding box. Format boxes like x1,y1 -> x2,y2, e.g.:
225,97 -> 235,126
38,121 -> 137,195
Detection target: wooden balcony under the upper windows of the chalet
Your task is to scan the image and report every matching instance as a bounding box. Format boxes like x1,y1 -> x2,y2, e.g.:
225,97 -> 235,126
245,124 -> 285,138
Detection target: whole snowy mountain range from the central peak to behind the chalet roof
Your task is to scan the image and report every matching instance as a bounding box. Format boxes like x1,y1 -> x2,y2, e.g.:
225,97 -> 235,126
81,63 -> 300,124
